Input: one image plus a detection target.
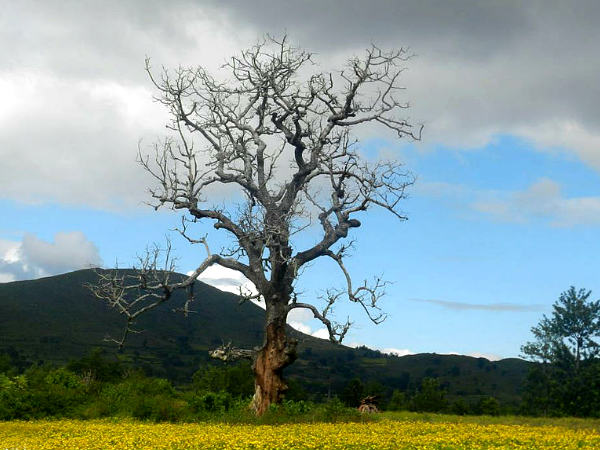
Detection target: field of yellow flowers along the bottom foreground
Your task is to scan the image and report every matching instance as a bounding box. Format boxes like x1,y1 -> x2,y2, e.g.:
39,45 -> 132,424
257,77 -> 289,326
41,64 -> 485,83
0,420 -> 600,450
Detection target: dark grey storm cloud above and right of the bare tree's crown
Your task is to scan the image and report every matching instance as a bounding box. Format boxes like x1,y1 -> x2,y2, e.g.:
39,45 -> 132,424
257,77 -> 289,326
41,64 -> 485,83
211,0 -> 600,165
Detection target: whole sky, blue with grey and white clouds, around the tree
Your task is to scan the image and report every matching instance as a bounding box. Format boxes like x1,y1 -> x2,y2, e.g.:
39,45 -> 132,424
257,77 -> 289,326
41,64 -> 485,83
0,0 -> 600,359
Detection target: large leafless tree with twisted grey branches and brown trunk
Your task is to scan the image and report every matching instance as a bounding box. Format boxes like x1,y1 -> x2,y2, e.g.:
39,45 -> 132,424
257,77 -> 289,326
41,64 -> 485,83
94,37 -> 421,414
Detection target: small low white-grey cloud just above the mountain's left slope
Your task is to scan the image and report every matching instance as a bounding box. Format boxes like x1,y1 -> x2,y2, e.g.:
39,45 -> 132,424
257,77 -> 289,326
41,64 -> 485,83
0,231 -> 102,281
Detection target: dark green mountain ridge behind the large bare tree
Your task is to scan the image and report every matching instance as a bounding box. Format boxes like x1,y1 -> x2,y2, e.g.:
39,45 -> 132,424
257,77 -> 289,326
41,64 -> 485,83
0,270 -> 529,405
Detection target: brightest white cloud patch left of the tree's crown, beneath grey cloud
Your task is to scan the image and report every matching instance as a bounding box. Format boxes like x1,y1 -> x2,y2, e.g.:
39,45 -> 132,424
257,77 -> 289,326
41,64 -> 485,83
0,72 -> 164,209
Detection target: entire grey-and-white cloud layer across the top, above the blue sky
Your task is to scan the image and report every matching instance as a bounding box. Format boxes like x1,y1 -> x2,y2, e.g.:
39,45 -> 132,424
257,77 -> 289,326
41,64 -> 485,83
0,0 -> 600,208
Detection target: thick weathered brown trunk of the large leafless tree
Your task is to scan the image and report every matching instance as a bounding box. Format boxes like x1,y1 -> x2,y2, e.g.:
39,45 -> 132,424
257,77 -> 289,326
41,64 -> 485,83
252,305 -> 297,416
